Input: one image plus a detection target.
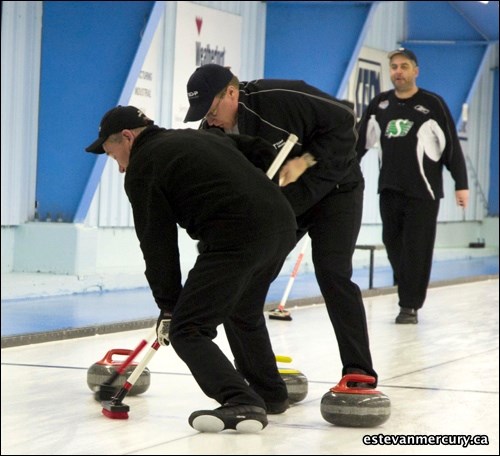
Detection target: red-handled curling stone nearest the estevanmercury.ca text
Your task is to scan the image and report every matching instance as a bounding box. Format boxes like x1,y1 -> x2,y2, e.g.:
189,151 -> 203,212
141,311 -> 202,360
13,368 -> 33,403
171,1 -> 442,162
321,374 -> 391,427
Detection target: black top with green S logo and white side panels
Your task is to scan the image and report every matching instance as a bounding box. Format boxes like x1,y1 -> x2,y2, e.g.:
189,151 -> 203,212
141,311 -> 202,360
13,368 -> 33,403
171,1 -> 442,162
357,88 -> 468,200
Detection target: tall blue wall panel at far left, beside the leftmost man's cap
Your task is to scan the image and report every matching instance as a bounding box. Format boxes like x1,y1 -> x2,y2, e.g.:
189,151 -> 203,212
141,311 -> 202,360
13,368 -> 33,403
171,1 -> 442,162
36,1 -> 155,222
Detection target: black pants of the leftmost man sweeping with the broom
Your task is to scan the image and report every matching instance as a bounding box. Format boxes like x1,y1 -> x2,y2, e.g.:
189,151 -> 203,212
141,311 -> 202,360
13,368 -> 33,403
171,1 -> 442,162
170,231 -> 296,408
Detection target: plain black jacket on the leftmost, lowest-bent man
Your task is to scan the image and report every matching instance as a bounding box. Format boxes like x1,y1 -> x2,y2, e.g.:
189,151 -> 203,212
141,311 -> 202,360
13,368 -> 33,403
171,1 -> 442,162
125,126 -> 296,311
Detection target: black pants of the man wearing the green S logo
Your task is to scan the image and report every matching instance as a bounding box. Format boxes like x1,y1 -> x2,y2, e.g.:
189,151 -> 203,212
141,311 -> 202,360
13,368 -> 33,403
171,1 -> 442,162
379,190 -> 440,309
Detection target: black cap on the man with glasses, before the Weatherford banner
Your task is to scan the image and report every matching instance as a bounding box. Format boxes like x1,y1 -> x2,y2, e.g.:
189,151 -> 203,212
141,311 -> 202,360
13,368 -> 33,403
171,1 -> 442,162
184,63 -> 233,122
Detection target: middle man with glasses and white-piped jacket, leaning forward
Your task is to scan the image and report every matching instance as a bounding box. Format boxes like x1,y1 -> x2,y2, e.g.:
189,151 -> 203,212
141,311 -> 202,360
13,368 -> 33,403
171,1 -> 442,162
185,64 -> 377,387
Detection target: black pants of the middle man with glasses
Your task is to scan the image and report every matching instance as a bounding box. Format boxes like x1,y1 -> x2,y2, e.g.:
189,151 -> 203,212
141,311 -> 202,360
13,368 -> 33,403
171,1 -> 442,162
297,181 -> 377,378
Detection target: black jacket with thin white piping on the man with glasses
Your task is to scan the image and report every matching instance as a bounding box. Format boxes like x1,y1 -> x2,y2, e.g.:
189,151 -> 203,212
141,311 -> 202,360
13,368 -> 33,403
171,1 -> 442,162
200,79 -> 363,215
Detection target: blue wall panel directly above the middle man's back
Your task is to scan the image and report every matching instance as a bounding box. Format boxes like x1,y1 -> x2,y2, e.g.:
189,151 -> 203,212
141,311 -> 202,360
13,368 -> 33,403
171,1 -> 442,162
264,2 -> 370,95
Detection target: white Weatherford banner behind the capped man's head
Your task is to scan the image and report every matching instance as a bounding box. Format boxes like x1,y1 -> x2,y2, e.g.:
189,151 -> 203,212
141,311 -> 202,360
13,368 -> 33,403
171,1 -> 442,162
172,2 -> 241,128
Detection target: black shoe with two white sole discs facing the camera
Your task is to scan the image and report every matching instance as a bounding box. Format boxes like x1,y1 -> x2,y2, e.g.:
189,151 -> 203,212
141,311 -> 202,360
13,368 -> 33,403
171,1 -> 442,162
189,404 -> 267,433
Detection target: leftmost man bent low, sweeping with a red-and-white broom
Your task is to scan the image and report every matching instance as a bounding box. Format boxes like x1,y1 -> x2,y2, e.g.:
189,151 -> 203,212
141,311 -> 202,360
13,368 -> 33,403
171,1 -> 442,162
86,106 -> 296,432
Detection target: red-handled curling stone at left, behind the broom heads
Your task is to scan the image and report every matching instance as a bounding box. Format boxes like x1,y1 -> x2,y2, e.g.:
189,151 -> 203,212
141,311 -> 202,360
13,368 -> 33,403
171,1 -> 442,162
87,348 -> 151,396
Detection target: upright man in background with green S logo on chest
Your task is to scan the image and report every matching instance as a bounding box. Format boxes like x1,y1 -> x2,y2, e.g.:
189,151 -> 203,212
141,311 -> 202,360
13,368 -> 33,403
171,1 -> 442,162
357,48 -> 469,324
